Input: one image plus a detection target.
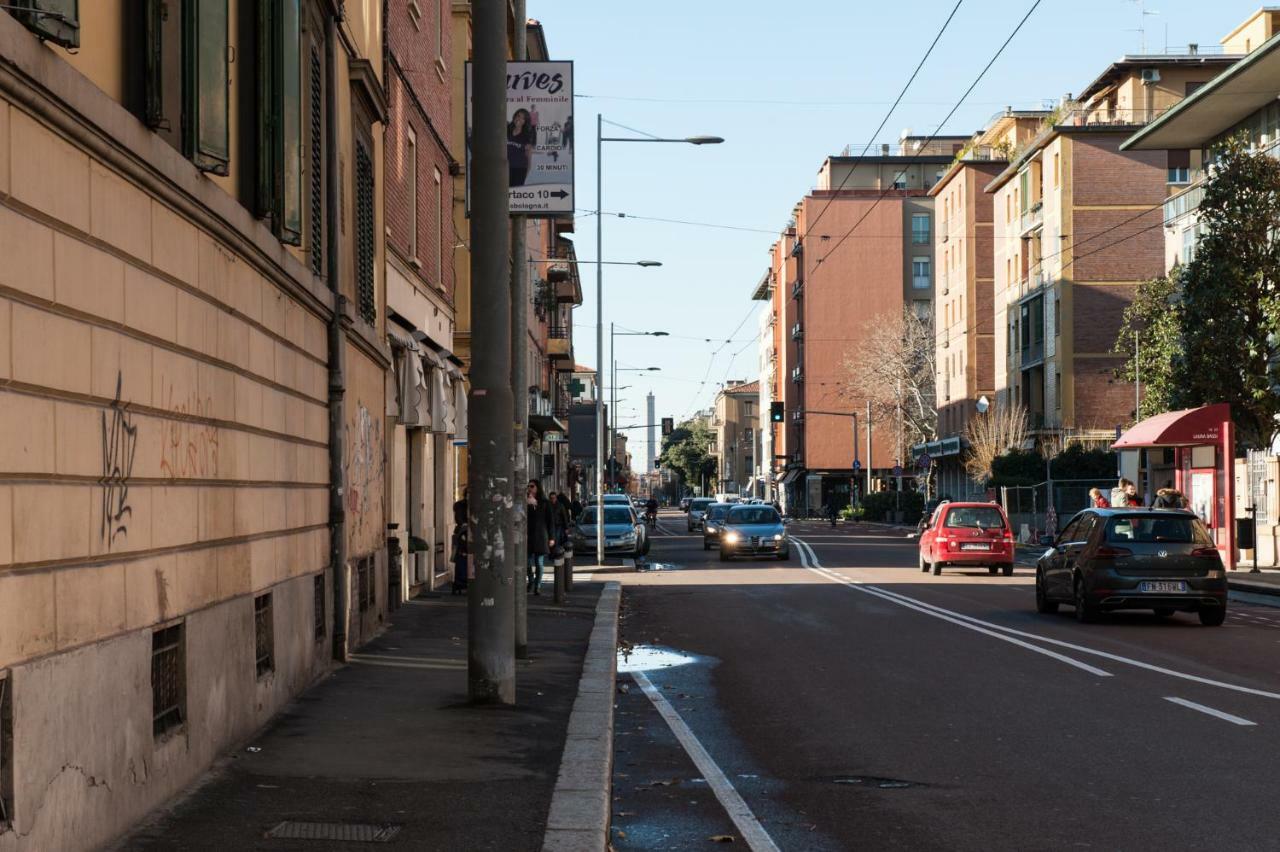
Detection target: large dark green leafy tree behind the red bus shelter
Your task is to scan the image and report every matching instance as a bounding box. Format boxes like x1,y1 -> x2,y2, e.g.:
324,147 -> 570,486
1115,138 -> 1280,446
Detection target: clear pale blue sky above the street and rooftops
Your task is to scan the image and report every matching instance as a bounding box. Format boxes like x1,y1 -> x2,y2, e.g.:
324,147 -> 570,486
527,0 -> 1257,459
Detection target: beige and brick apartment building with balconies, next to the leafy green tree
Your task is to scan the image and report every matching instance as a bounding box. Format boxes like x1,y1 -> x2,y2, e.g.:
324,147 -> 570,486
987,47 -> 1238,440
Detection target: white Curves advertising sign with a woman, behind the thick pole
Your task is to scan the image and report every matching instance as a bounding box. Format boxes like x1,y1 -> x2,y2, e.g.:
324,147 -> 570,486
466,61 -> 573,217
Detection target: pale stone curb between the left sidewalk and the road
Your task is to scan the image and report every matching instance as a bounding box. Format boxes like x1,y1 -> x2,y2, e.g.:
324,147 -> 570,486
543,582 -> 622,852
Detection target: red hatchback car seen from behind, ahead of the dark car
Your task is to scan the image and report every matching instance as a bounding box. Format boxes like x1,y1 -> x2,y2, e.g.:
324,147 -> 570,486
920,503 -> 1016,577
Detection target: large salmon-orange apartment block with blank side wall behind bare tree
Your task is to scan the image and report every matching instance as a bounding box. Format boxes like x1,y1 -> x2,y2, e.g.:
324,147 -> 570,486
776,136 -> 969,510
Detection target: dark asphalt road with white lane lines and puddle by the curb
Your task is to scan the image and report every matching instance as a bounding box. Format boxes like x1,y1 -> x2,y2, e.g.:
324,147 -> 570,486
611,513 -> 1280,852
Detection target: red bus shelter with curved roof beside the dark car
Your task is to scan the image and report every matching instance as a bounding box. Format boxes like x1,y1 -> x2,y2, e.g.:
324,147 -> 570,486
1111,403 -> 1235,571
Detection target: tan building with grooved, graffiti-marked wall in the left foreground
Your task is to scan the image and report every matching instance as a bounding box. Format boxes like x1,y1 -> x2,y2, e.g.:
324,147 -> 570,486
0,6 -> 390,852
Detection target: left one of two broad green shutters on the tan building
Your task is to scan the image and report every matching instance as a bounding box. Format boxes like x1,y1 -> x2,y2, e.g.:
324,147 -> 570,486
183,0 -> 230,174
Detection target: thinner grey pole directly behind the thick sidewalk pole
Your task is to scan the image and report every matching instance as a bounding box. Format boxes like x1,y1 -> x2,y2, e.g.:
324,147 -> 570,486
503,0 -> 529,660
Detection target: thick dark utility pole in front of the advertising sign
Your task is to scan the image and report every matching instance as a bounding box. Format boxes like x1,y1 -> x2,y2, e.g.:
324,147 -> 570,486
467,0 -> 516,704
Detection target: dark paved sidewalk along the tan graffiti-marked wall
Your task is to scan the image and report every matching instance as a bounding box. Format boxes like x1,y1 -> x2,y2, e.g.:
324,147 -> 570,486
116,582 -> 617,852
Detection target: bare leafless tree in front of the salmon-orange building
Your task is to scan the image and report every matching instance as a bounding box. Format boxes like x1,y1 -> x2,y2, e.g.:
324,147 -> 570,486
841,308 -> 938,449
